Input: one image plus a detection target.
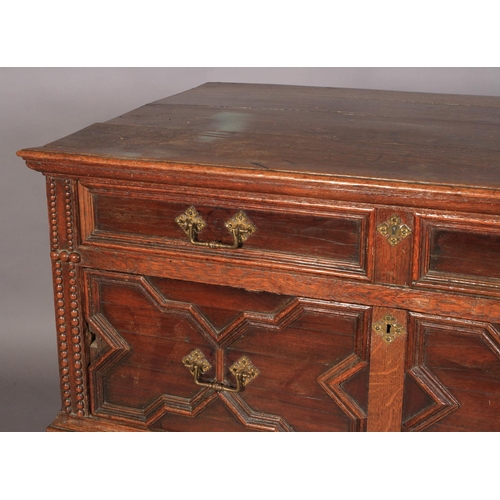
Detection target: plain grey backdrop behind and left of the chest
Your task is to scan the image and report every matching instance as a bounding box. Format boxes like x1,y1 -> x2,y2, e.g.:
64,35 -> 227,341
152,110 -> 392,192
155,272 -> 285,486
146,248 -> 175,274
0,68 -> 500,431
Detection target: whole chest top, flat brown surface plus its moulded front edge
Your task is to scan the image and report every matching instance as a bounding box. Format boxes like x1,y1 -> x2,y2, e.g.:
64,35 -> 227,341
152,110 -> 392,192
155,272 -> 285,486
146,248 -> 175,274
18,83 -> 500,219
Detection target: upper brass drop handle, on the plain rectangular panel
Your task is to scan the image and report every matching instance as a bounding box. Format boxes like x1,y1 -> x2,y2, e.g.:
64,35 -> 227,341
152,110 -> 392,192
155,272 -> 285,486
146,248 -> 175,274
175,207 -> 257,249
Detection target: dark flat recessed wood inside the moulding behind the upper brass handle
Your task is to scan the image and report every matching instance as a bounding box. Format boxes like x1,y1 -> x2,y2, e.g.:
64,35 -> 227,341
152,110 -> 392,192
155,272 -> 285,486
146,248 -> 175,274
93,194 -> 365,268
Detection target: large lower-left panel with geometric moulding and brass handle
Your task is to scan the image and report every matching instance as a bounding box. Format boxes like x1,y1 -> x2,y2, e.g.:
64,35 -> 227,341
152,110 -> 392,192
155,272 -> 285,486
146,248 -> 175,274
84,270 -> 371,431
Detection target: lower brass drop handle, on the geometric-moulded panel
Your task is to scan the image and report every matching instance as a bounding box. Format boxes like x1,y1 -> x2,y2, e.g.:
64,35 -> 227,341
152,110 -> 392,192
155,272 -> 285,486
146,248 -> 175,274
182,349 -> 259,392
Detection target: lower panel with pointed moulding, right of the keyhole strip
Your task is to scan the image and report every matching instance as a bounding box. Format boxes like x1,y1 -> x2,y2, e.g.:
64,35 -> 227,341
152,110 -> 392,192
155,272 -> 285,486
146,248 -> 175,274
403,313 -> 500,432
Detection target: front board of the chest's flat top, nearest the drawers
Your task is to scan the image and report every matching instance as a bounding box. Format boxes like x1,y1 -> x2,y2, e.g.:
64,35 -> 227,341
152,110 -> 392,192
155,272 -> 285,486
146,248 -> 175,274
18,124 -> 500,189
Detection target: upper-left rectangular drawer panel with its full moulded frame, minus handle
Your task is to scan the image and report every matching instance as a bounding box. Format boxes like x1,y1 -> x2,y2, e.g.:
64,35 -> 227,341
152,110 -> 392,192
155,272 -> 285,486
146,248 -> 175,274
79,184 -> 373,279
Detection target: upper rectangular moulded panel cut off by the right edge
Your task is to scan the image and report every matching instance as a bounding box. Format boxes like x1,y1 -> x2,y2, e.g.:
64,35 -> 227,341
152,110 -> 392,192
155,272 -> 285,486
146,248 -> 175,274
413,214 -> 500,295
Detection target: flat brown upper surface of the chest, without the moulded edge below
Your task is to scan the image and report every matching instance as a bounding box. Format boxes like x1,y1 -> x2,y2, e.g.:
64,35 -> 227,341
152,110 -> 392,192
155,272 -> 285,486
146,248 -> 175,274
17,83 -> 500,188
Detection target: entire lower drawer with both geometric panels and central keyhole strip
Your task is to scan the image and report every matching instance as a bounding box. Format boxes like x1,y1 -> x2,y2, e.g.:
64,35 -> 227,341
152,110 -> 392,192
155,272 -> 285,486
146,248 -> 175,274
82,269 -> 500,431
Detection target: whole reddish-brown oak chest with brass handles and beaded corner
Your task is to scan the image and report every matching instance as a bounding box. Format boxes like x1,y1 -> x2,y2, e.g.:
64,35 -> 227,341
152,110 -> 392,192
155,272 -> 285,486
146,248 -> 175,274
18,83 -> 500,431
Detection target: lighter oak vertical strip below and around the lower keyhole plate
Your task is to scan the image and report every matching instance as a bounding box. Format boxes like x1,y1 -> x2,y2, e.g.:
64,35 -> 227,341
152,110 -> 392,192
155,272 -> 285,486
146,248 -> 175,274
368,307 -> 407,432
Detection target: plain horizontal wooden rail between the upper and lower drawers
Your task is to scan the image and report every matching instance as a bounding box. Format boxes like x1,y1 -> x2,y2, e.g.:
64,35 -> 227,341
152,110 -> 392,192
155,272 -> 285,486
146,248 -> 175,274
81,245 -> 500,322
